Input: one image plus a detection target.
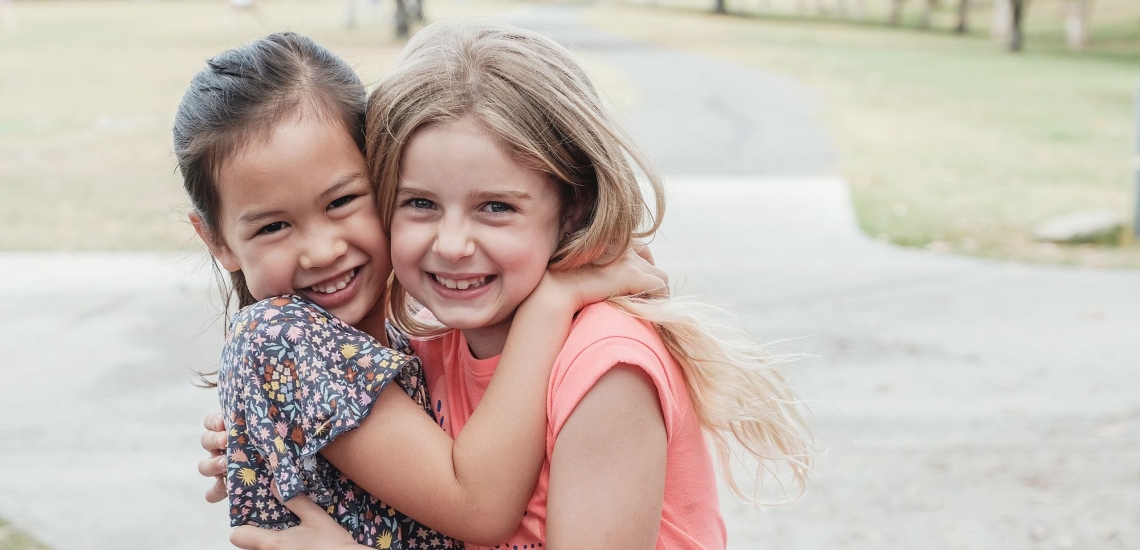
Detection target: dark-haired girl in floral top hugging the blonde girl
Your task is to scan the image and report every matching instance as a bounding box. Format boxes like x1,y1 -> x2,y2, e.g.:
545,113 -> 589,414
174,33 -> 660,549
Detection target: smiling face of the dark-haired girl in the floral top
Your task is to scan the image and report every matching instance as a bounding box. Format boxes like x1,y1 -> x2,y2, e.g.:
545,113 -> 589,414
195,115 -> 392,325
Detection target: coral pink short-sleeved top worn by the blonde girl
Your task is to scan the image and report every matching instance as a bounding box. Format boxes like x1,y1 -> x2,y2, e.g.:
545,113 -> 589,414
413,304 -> 727,550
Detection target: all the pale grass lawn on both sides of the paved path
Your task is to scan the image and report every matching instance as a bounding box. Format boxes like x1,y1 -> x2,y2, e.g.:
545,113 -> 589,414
0,0 -> 1140,266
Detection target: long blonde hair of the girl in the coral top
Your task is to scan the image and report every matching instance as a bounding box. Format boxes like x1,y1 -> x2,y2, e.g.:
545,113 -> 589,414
365,21 -> 811,501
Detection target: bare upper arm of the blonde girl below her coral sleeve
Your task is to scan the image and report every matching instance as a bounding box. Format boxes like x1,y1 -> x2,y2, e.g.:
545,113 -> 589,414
546,364 -> 666,550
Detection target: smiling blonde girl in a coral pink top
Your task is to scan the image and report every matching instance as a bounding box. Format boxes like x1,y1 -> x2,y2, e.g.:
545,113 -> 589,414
222,22 -> 809,549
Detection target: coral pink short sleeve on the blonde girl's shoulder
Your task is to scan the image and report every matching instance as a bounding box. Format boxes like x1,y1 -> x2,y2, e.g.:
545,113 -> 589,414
547,335 -> 684,440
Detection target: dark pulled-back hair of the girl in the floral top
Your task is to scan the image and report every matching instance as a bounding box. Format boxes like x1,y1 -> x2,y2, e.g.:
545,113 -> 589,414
173,32 -> 366,385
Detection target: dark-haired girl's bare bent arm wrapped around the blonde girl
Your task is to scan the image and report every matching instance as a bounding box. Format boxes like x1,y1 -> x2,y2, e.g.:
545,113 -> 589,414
321,253 -> 663,545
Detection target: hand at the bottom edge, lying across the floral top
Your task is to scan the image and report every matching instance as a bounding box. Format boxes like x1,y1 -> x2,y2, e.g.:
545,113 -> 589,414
229,491 -> 368,550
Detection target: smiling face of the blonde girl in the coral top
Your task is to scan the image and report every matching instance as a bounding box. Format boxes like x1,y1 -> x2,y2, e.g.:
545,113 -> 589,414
391,118 -> 562,357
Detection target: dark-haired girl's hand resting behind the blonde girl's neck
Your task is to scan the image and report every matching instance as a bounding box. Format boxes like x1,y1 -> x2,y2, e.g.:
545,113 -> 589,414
528,245 -> 669,310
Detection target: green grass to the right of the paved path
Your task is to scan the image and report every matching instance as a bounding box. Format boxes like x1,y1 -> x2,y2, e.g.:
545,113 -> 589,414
592,0 -> 1140,266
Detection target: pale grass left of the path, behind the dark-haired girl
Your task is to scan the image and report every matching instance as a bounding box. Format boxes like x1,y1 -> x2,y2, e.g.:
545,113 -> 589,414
0,0 -> 508,250
